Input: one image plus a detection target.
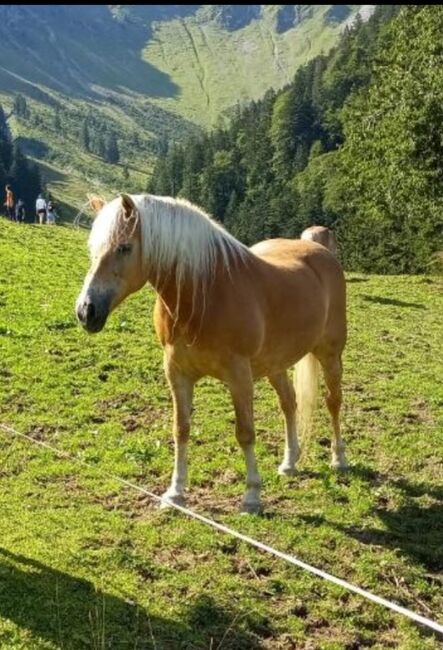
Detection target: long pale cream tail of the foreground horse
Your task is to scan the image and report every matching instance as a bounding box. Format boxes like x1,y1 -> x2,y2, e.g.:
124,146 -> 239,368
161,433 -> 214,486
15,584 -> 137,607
294,352 -> 320,454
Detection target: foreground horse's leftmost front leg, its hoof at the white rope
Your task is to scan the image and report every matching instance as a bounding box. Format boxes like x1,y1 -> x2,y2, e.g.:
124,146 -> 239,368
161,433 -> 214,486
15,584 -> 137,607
162,355 -> 194,507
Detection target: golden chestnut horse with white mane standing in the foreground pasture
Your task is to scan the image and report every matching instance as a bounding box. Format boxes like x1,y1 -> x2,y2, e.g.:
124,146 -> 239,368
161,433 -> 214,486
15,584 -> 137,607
76,194 -> 347,512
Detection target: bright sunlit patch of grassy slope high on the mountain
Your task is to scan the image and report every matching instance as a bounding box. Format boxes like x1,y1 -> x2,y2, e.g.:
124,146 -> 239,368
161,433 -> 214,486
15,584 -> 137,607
144,5 -> 357,126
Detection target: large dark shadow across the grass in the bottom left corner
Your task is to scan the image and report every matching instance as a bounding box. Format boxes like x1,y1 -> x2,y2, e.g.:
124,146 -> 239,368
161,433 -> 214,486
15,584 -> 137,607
0,548 -> 269,650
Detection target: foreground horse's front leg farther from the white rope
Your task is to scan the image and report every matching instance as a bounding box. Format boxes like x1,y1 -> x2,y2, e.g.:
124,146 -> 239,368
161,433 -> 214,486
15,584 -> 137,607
227,359 -> 262,513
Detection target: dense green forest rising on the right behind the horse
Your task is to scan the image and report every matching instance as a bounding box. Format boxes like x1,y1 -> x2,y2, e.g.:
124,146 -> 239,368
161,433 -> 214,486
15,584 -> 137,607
148,5 -> 443,273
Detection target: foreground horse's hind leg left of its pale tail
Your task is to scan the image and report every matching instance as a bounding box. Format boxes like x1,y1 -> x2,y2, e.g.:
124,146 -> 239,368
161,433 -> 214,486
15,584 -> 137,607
269,371 -> 300,476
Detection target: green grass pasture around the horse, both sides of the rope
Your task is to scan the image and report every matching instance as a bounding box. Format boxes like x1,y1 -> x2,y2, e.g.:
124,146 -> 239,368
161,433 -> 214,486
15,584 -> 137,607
0,220 -> 443,650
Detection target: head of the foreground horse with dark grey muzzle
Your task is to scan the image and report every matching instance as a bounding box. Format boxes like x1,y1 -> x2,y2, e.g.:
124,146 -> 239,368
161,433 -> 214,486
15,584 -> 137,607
76,194 -> 146,333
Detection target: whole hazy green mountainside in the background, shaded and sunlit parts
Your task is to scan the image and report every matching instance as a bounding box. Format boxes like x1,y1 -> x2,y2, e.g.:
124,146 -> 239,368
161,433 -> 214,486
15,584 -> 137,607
0,5 -> 373,218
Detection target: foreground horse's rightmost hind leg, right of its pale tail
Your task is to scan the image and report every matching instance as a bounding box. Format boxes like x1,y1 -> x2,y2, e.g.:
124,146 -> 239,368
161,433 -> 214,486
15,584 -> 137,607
320,355 -> 348,469
